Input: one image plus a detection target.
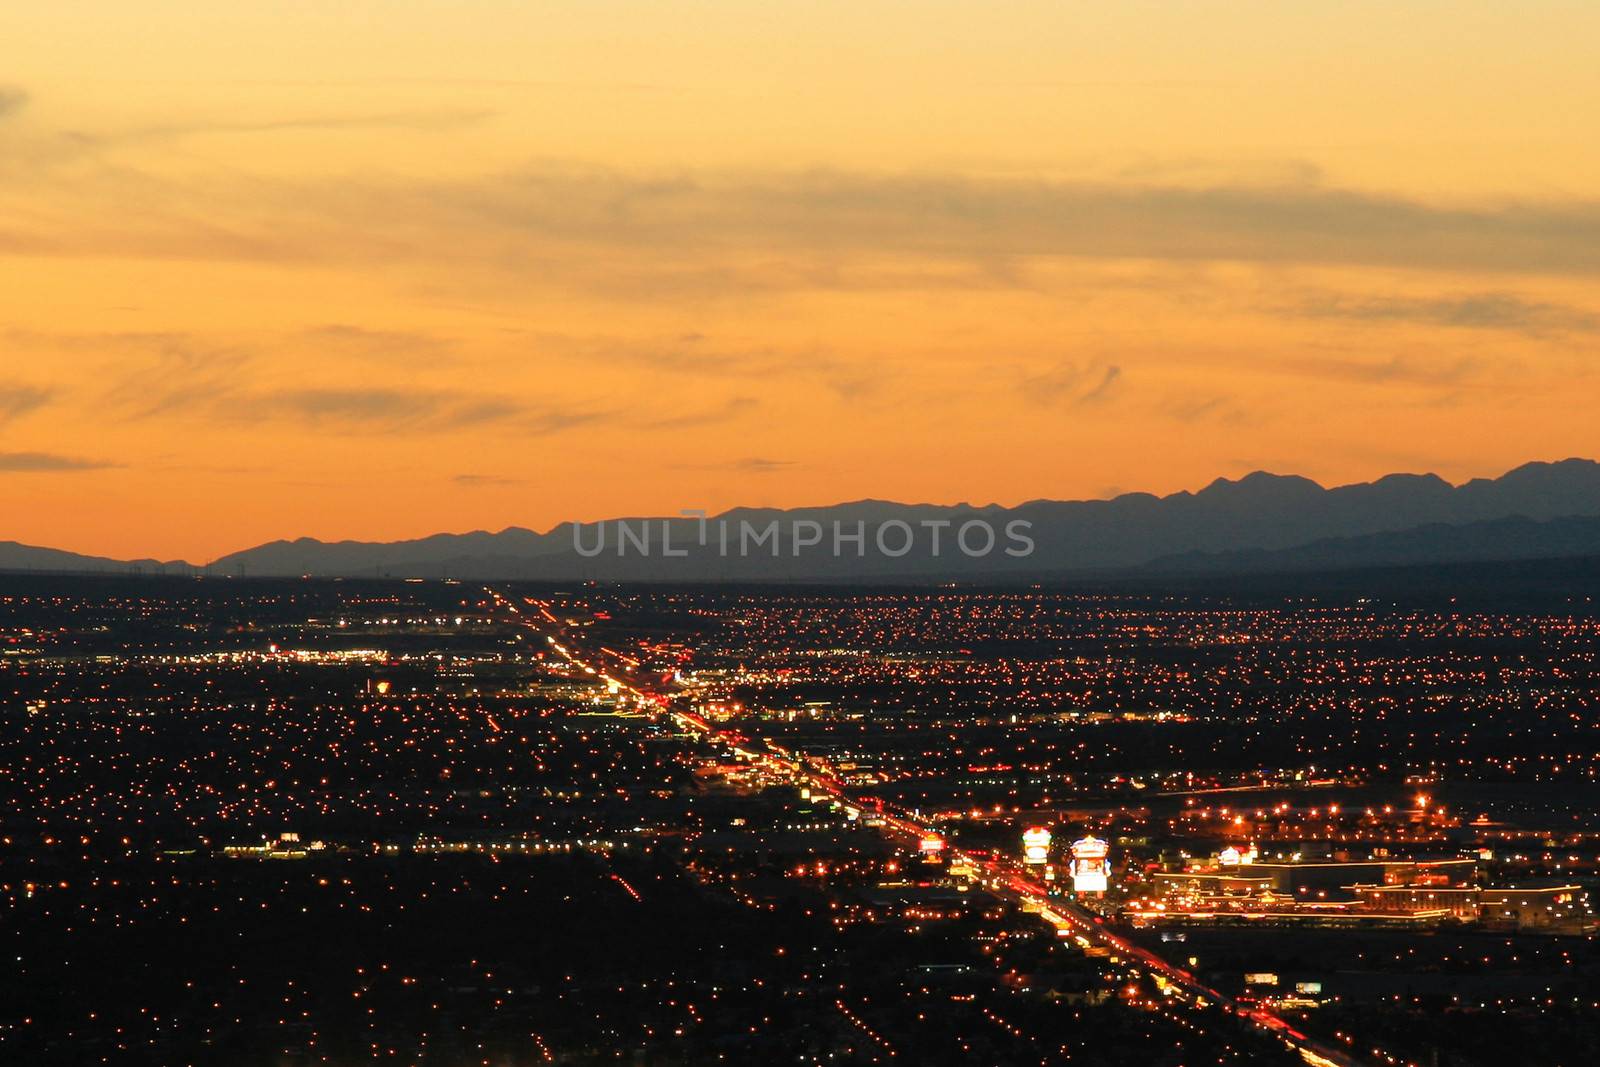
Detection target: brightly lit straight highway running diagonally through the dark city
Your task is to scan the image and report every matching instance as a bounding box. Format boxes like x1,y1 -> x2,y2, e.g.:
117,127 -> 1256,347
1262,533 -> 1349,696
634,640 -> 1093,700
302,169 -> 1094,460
488,590 -> 1363,1067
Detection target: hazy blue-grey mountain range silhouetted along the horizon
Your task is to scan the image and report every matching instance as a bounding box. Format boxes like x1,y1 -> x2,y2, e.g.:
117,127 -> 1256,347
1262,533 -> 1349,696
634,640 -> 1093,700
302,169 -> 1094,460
9,459 -> 1600,581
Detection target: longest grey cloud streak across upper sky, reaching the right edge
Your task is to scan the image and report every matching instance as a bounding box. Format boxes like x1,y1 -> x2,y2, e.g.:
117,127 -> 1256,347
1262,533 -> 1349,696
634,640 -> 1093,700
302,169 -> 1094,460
387,168 -> 1600,283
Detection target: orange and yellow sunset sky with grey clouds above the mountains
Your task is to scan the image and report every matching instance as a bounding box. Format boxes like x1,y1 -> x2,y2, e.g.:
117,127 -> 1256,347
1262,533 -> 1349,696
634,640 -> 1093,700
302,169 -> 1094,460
0,0 -> 1600,561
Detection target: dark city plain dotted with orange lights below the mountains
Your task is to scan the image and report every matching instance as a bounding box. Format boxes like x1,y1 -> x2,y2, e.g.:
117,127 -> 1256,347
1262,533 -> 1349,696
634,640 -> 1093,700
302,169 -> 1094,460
12,572 -> 1600,1067
